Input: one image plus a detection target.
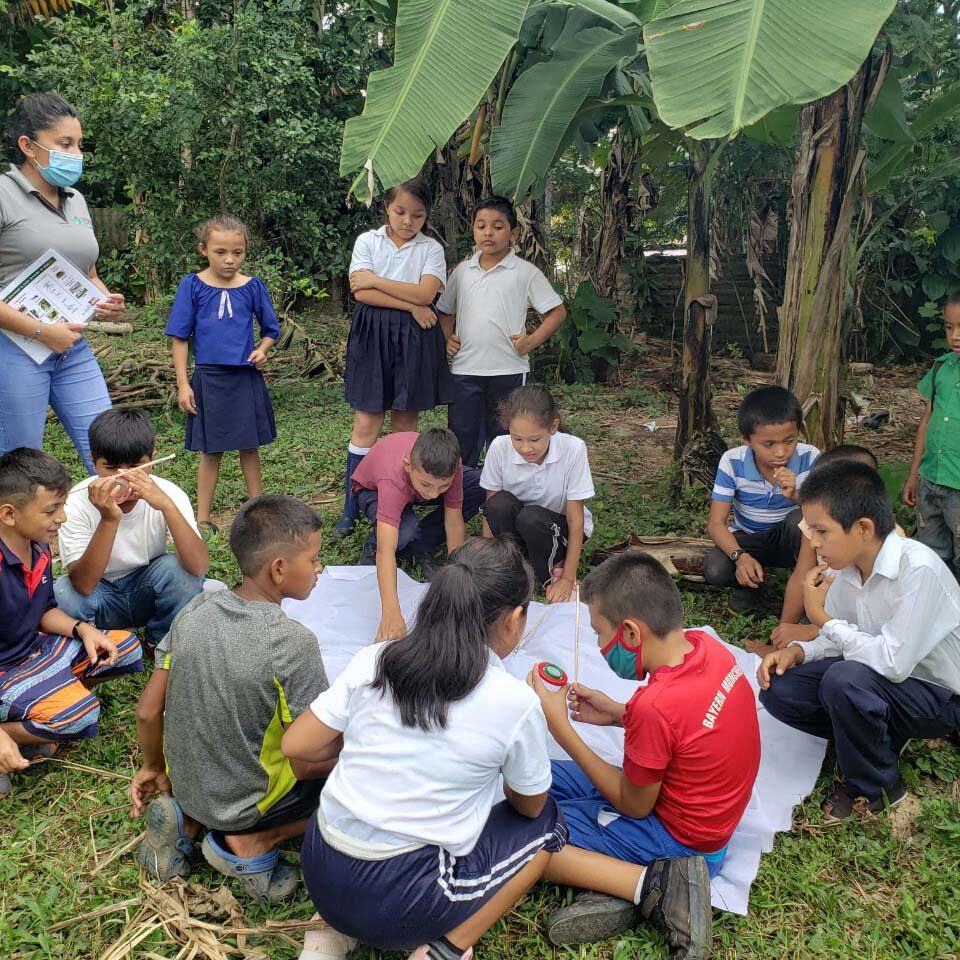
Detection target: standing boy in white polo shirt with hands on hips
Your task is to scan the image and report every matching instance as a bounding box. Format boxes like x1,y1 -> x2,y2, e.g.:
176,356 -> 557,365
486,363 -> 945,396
437,197 -> 567,467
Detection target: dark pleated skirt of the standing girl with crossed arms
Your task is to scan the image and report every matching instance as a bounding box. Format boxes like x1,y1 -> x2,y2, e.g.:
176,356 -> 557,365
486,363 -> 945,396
344,303 -> 453,413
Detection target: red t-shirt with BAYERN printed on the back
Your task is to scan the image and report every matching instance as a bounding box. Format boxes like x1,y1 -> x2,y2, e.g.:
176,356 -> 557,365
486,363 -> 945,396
623,630 -> 760,853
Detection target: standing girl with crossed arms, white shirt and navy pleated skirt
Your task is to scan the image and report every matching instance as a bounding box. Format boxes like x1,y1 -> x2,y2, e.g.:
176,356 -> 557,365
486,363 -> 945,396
334,180 -> 453,537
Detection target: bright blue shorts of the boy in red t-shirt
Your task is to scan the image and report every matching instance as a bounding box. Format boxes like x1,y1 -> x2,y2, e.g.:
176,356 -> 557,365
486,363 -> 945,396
550,760 -> 727,877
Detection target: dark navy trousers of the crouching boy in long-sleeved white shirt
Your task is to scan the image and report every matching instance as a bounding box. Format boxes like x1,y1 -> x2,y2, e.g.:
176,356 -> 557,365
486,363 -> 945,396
760,657 -> 960,800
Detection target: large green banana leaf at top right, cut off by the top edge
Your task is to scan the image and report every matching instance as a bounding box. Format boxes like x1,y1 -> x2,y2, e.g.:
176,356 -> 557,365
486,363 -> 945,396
643,0 -> 896,140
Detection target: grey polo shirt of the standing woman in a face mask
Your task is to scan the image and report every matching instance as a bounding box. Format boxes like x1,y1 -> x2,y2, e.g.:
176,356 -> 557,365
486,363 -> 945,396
0,166 -> 100,290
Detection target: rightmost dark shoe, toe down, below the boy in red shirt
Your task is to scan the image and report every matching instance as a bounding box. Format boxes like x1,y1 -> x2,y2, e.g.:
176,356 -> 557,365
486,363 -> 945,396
640,857 -> 713,960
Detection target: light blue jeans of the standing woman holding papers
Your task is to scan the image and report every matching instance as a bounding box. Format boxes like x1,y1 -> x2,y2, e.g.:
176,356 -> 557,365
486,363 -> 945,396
0,334 -> 110,474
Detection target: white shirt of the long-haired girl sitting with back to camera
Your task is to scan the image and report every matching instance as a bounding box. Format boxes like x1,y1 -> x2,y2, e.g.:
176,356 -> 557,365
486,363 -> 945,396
310,643 -> 551,860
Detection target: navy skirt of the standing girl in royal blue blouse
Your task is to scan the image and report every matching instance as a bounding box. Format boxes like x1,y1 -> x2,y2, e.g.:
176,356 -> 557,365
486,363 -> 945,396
184,364 -> 277,453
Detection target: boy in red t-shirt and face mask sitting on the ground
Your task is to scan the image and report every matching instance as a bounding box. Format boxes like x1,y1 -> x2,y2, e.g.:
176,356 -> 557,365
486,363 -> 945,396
531,551 -> 760,958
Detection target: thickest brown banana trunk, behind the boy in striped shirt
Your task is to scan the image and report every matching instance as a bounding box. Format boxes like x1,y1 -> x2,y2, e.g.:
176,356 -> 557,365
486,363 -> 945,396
777,54 -> 889,449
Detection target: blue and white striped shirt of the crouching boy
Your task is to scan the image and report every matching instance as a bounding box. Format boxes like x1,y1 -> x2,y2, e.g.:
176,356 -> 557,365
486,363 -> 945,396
711,443 -> 820,533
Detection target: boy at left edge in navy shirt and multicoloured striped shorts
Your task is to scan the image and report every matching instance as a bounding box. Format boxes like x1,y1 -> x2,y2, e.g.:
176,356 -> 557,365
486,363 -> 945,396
0,447 -> 143,797
